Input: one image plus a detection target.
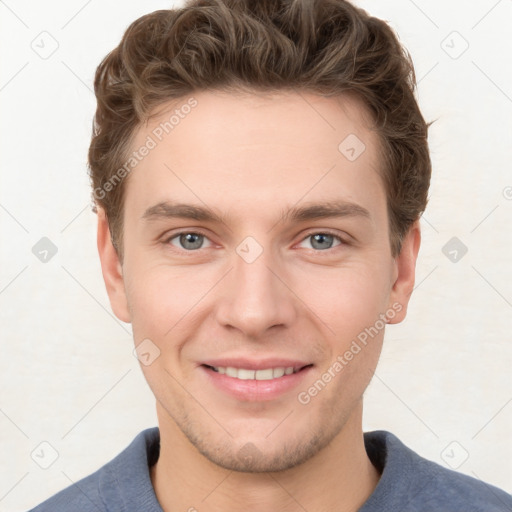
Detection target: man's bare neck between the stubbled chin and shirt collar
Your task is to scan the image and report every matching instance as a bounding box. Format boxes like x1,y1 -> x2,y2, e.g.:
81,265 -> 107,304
150,402 -> 380,512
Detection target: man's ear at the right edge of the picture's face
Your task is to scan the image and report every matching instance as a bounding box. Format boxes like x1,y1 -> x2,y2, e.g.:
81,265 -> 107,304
388,219 -> 421,324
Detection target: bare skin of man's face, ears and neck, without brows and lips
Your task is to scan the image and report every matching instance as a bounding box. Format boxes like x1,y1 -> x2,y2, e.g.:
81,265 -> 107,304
98,91 -> 420,512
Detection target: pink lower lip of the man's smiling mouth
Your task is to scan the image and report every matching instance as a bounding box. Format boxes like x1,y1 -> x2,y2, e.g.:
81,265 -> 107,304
199,366 -> 312,402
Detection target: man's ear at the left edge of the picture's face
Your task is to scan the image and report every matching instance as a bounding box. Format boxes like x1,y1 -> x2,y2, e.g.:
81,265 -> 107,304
97,206 -> 130,323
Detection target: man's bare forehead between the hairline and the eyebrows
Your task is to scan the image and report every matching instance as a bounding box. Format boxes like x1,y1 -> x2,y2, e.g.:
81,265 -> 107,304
125,91 -> 385,226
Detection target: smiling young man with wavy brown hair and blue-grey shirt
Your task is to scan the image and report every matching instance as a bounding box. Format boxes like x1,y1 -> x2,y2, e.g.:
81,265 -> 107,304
29,0 -> 512,512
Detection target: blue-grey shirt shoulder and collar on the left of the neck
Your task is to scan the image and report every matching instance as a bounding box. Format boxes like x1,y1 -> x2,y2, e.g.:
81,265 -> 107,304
29,427 -> 161,512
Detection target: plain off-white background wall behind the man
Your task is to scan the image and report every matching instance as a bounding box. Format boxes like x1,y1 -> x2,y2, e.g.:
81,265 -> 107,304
0,0 -> 512,511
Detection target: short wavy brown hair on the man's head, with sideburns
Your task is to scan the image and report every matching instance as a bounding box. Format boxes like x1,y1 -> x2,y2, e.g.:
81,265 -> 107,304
88,0 -> 431,261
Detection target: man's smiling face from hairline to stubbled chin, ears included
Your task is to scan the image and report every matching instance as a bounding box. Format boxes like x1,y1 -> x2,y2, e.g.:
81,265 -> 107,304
98,91 -> 419,471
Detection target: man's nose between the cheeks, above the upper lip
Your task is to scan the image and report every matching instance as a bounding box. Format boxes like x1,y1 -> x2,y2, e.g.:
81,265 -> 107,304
217,242 -> 298,339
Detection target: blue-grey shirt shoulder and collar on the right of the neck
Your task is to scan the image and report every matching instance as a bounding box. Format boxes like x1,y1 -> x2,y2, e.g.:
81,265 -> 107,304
361,430 -> 512,512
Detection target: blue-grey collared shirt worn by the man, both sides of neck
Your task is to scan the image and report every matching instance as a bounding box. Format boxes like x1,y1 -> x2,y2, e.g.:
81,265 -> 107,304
30,427 -> 512,512
